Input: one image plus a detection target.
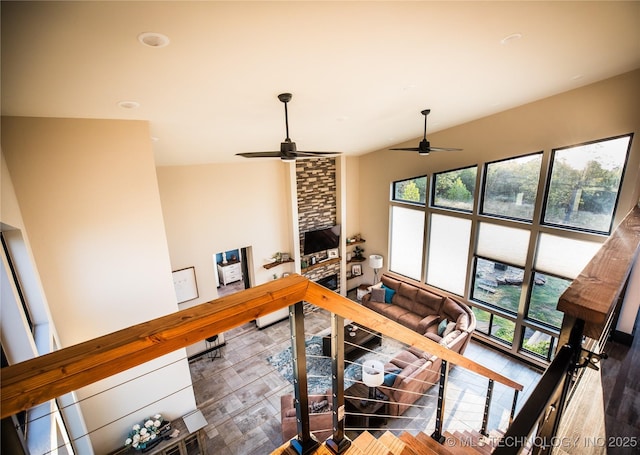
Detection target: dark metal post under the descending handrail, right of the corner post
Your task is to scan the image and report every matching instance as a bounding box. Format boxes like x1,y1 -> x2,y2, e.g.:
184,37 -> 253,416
326,313 -> 351,453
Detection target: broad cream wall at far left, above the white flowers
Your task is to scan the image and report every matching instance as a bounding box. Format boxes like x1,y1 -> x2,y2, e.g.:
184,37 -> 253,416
2,117 -> 195,453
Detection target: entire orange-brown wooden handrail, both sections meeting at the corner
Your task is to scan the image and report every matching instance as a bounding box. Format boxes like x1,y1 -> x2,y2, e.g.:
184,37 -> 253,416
0,274 -> 523,418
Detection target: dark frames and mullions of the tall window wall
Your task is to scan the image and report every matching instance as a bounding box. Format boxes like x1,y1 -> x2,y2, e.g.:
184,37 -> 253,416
389,133 -> 633,367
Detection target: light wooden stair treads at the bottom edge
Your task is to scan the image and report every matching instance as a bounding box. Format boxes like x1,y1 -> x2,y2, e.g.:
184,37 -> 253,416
271,430 -> 510,455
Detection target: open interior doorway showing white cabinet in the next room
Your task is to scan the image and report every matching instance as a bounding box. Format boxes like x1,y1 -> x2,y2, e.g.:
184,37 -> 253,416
213,247 -> 251,297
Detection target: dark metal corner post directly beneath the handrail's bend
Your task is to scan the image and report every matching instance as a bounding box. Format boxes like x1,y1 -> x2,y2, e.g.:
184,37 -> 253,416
289,302 -> 319,455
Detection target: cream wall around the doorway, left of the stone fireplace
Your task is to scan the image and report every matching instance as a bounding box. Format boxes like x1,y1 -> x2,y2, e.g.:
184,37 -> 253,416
157,159 -> 294,344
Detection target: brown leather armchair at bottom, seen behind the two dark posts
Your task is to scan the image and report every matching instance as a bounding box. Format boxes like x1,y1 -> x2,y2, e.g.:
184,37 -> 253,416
280,392 -> 333,442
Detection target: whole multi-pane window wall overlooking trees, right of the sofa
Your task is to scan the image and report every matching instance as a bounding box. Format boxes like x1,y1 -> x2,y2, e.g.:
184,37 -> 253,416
390,135 -> 632,360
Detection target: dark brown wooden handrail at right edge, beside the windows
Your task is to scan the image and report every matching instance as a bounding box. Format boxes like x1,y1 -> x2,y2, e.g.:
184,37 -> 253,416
557,206 -> 640,340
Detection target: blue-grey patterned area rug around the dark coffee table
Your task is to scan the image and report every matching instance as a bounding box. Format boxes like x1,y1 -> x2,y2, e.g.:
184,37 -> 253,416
267,335 -> 404,394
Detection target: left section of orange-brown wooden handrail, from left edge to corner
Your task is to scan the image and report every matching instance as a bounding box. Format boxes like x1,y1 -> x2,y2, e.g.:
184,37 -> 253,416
0,275 -> 309,419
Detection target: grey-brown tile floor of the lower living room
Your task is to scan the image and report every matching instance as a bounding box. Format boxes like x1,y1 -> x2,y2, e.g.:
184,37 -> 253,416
190,305 -> 540,455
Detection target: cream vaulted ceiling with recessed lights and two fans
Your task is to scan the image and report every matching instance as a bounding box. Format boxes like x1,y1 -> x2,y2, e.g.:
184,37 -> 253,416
1,1 -> 640,165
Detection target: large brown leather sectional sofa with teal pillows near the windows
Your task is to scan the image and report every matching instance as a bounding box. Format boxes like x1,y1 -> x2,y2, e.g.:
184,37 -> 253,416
362,274 -> 476,416
